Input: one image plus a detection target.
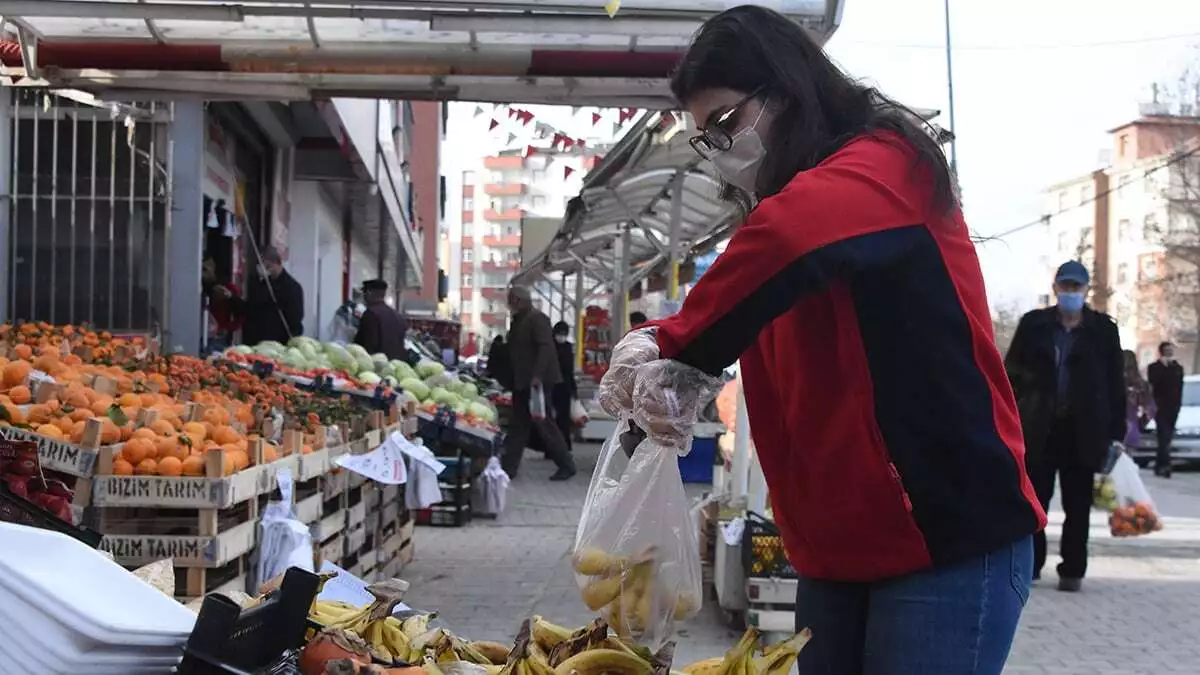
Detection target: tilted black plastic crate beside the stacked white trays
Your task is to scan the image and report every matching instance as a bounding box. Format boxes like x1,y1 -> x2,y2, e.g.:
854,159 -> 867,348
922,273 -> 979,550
175,567 -> 318,675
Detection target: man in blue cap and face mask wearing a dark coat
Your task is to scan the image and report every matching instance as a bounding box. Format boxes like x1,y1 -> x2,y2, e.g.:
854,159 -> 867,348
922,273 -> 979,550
1004,261 -> 1126,591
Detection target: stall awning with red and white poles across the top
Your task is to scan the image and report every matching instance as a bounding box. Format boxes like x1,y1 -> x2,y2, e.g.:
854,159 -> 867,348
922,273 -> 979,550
0,0 -> 844,108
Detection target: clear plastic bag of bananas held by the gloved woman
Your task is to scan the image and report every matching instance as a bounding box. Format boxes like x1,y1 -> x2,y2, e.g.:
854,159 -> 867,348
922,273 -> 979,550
571,417 -> 702,646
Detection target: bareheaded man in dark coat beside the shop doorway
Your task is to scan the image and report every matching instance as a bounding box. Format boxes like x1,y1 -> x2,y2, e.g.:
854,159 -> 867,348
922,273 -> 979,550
229,247 -> 304,345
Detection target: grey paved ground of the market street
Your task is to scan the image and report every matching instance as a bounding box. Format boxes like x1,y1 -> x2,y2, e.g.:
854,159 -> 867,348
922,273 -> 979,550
403,446 -> 1200,675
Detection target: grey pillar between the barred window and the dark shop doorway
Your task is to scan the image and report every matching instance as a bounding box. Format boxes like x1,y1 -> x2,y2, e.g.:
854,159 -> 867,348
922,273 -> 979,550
163,101 -> 206,354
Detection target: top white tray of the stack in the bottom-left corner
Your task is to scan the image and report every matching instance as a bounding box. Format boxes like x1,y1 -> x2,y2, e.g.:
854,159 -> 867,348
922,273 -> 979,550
0,522 -> 196,646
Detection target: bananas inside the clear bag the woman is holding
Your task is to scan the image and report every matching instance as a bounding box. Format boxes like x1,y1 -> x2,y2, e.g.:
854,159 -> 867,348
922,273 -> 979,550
571,546 -> 700,638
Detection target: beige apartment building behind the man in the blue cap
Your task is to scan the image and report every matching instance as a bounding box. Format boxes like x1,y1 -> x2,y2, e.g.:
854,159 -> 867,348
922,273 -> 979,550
1039,110 -> 1200,365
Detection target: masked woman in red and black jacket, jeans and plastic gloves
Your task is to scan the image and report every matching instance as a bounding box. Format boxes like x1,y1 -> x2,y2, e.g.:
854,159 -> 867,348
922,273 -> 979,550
601,6 -> 1045,675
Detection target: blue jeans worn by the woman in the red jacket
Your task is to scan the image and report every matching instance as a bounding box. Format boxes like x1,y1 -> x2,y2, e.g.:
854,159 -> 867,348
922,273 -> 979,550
796,537 -> 1033,675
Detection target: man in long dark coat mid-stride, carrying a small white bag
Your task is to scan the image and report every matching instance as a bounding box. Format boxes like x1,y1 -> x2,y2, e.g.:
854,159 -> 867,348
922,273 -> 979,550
502,286 -> 575,480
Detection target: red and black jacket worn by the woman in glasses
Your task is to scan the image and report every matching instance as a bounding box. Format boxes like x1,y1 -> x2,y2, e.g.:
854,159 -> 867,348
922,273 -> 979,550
656,136 -> 1045,581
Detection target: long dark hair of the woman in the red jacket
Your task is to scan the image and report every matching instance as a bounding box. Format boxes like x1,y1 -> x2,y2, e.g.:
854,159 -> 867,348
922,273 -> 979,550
671,5 -> 958,211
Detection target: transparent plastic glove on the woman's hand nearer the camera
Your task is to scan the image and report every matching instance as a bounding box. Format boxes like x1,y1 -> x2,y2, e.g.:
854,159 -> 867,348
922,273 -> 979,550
634,359 -> 724,455
